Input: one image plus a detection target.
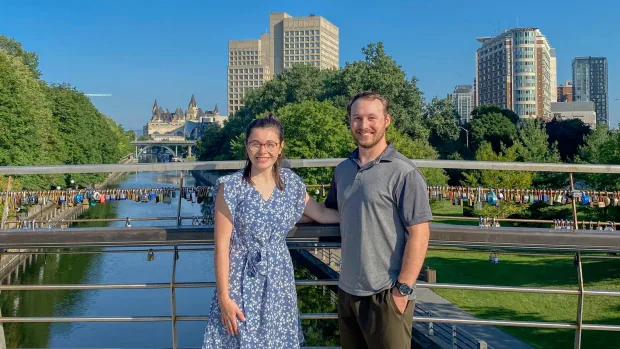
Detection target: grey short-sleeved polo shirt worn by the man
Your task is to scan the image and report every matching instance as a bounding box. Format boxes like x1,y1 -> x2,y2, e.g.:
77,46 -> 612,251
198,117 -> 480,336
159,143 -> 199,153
325,143 -> 433,299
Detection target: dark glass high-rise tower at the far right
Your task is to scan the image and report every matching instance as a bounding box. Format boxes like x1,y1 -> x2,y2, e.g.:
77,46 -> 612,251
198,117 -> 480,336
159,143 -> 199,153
573,57 -> 609,127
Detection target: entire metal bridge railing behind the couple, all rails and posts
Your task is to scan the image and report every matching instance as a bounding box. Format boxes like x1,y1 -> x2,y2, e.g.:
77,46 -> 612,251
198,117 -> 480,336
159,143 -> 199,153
0,159 -> 620,349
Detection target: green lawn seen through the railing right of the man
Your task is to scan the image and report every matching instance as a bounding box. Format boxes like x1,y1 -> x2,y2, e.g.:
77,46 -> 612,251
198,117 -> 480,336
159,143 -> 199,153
426,250 -> 620,349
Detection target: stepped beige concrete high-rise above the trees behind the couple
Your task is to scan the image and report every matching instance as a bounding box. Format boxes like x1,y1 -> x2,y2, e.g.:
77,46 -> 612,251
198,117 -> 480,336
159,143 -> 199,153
228,12 -> 339,115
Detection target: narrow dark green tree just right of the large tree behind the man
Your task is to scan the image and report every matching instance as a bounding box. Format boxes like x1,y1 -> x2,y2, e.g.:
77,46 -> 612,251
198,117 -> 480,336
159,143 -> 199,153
425,97 -> 461,159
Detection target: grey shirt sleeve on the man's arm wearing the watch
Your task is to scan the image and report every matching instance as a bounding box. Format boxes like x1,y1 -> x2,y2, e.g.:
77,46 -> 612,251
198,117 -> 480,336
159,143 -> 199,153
394,169 -> 433,227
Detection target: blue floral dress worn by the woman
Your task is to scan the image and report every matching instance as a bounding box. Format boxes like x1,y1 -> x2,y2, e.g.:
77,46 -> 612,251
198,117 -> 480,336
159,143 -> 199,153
203,169 -> 306,349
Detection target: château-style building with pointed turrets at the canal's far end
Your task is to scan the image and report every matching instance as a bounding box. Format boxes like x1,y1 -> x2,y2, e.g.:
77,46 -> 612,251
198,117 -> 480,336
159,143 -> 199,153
144,95 -> 226,139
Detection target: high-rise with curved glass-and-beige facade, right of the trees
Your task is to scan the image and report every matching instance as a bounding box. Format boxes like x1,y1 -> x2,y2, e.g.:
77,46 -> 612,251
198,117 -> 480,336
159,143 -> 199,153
476,28 -> 556,118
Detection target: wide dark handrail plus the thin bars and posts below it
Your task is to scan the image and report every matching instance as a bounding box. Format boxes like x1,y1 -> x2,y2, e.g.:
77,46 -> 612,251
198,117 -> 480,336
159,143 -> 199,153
0,224 -> 620,348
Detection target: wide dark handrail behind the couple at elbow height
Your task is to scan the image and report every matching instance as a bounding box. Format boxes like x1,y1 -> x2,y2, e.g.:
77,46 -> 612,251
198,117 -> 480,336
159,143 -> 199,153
0,224 -> 620,252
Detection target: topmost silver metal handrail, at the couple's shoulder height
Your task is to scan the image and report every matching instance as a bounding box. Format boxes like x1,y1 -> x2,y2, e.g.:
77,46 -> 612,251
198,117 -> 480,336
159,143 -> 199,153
0,158 -> 620,175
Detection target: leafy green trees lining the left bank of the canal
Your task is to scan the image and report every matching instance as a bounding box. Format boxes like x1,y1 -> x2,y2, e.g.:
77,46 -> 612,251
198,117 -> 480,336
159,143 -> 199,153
0,35 -> 134,189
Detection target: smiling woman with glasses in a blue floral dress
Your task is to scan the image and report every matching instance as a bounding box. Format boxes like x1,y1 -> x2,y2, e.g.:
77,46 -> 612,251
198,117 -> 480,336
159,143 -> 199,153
203,115 -> 339,349
